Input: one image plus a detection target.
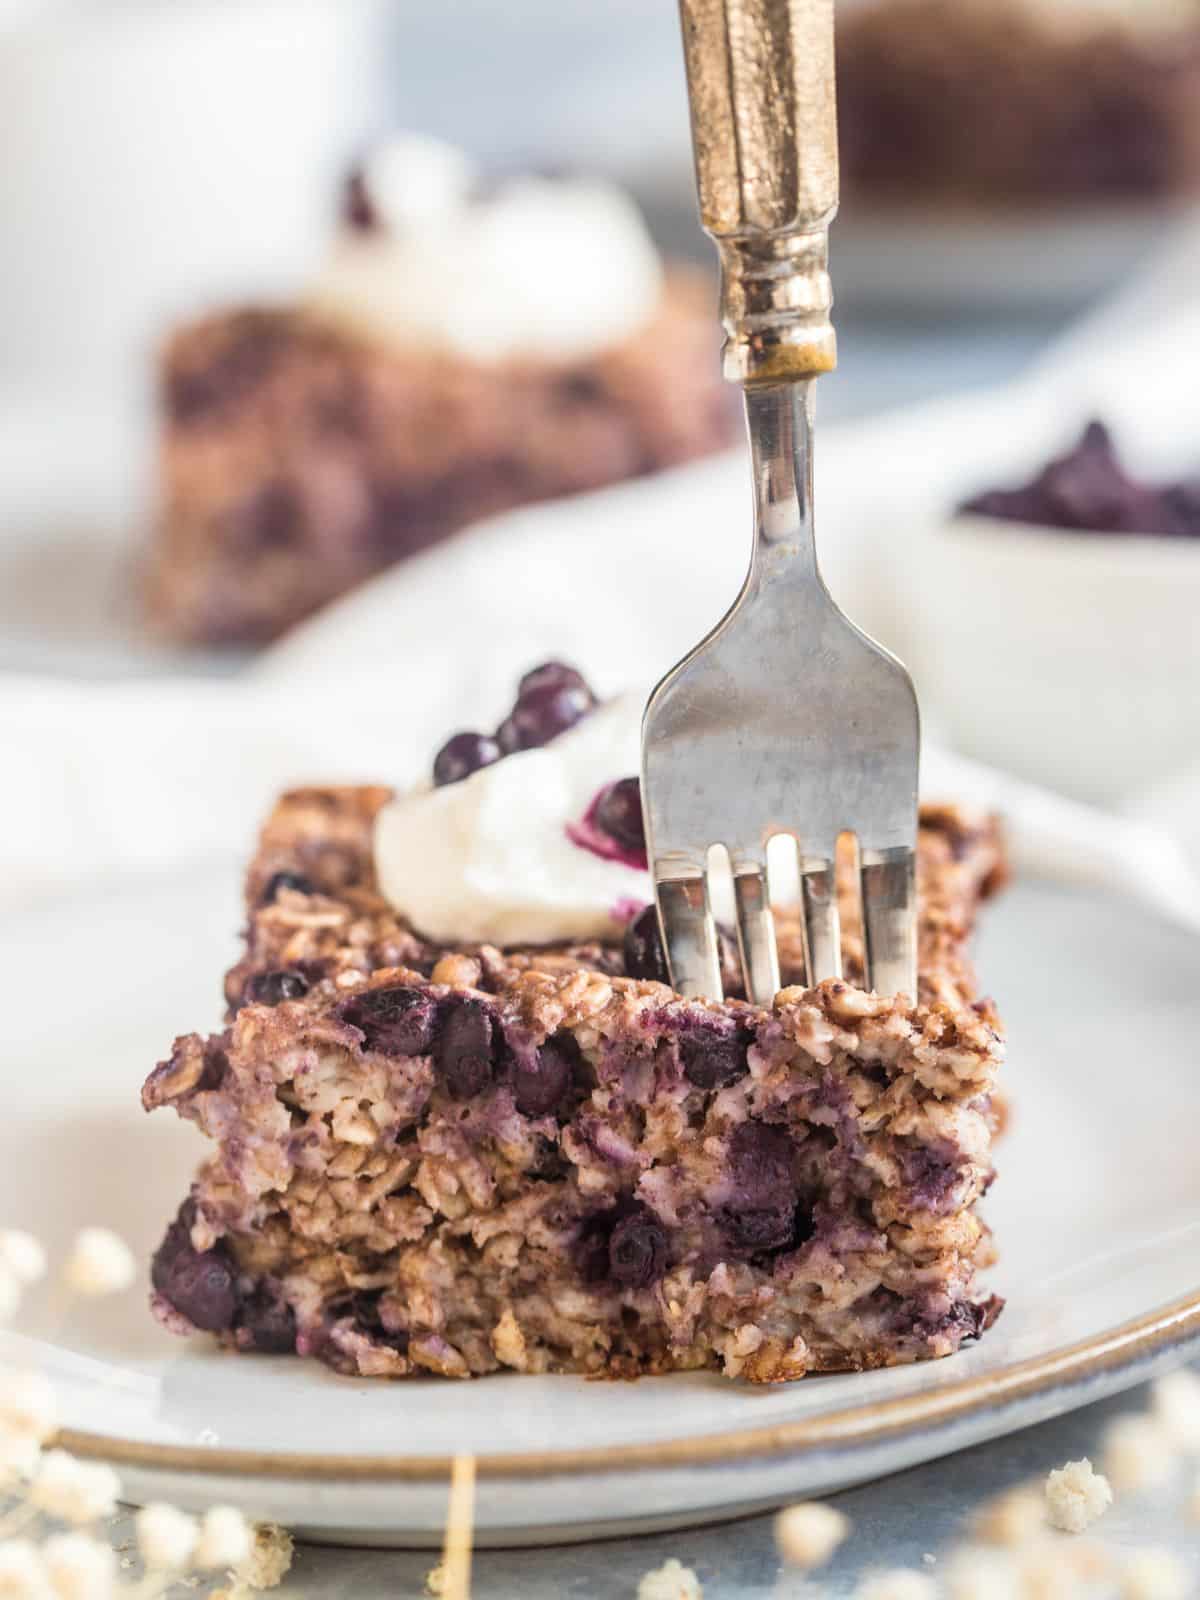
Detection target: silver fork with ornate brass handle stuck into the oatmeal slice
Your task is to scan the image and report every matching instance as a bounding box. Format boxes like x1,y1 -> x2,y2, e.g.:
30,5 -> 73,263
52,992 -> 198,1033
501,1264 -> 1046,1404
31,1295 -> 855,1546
642,0 -> 920,1005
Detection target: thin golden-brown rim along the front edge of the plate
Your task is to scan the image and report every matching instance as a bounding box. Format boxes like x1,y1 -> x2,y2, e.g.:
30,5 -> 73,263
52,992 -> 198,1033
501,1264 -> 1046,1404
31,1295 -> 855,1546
58,1291 -> 1200,1483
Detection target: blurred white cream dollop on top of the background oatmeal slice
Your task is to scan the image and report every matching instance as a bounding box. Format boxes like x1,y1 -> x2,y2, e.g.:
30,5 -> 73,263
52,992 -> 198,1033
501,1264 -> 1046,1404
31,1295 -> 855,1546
307,136 -> 662,362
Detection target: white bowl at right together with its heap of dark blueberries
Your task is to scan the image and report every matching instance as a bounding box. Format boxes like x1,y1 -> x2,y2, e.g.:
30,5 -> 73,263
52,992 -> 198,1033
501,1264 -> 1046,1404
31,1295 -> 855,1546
888,419 -> 1200,805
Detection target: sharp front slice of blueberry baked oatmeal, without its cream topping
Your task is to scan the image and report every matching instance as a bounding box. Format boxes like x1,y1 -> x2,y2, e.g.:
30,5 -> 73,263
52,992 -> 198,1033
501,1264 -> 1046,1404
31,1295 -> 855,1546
142,668 -> 1005,1382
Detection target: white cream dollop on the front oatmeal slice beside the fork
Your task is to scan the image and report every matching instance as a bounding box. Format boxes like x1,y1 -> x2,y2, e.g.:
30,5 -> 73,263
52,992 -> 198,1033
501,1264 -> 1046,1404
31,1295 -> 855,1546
374,693 -> 653,946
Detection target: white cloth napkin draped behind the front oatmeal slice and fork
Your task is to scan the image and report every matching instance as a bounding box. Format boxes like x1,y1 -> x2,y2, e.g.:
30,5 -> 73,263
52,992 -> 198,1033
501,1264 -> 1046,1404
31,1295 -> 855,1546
0,230 -> 1200,931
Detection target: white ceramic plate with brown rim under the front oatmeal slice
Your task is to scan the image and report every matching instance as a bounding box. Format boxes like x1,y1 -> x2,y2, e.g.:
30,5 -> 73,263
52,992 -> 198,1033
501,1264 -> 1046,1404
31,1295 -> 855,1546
0,864 -> 1200,1544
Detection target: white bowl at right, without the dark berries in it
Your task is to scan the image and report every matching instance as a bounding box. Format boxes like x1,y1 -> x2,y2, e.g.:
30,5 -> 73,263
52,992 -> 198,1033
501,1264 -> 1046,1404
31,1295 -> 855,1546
890,515 -> 1200,803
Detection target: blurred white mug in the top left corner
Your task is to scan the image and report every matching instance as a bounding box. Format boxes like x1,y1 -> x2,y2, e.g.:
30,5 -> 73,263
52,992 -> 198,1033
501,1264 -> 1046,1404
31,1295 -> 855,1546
0,0 -> 382,395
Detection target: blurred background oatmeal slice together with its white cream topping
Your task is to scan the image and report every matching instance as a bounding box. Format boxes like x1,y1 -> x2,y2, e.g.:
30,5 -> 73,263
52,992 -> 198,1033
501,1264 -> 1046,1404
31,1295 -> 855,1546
146,138 -> 736,643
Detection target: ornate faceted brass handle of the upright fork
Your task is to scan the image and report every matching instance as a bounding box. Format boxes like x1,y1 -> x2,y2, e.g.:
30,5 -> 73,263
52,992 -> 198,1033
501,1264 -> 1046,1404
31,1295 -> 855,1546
680,0 -> 837,384
